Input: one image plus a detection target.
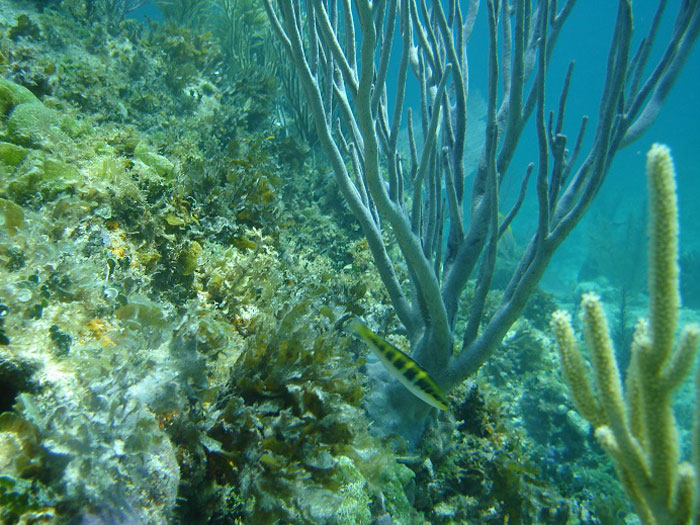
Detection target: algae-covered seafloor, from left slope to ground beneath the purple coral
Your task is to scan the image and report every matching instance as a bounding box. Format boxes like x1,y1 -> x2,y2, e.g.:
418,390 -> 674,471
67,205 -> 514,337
0,0 -> 692,524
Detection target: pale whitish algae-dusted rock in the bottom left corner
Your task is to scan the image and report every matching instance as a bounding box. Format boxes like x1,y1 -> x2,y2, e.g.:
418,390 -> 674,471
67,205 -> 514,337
17,386 -> 180,525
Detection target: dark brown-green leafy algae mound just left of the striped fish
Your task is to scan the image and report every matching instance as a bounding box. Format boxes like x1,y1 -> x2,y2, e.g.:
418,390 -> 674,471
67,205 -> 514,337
200,298 -> 413,524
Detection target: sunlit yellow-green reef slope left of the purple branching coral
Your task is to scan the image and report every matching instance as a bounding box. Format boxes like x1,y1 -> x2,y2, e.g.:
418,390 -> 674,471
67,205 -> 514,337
0,3 -> 416,523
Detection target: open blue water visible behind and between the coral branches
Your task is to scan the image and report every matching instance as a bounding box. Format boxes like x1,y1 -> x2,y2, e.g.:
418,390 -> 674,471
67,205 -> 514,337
132,0 -> 700,300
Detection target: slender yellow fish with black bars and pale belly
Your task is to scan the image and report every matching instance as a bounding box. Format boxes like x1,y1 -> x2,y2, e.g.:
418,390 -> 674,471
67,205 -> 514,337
348,318 -> 447,410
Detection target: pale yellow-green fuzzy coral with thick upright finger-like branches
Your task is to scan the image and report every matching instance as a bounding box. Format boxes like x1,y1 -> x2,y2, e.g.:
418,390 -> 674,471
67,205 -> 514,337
551,144 -> 700,524
